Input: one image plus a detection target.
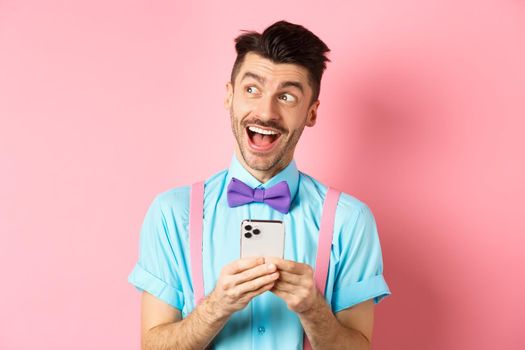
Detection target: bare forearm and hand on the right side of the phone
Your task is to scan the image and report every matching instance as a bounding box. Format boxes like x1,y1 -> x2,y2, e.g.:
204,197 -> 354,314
267,258 -> 374,350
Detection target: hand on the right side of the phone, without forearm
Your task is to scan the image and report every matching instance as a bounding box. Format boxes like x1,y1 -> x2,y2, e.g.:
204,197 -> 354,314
265,258 -> 324,314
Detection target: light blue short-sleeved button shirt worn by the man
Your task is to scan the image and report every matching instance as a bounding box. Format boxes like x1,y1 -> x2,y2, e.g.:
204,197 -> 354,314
128,155 -> 390,350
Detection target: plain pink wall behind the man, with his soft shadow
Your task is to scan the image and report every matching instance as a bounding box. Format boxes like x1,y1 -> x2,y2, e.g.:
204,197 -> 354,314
0,0 -> 525,350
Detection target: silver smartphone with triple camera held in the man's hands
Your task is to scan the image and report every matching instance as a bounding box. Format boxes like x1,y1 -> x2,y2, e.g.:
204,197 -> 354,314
241,220 -> 284,258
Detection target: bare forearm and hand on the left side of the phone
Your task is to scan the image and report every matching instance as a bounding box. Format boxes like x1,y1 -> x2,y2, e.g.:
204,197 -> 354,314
141,258 -> 279,350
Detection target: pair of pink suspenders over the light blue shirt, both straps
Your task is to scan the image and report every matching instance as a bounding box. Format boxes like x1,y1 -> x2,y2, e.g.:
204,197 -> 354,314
189,182 -> 340,350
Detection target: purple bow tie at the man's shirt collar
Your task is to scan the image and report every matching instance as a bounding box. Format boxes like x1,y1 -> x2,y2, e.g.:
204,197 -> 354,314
227,177 -> 292,214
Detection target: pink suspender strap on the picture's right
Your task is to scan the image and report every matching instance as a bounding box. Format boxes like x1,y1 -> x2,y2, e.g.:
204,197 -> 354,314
303,188 -> 341,350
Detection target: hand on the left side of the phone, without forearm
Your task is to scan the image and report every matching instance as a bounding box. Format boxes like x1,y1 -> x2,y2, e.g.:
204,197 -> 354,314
210,257 -> 279,317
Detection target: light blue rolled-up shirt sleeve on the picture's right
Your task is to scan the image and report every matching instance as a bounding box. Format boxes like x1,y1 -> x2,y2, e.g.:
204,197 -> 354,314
332,204 -> 391,312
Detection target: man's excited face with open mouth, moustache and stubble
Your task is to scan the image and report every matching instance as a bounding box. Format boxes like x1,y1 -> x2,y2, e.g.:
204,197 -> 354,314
225,52 -> 319,176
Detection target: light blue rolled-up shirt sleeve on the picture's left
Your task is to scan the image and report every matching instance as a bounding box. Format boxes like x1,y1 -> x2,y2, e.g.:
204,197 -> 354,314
128,196 -> 184,310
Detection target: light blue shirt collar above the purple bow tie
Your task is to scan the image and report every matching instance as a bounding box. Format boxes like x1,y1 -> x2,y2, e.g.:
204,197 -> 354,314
226,153 -> 299,200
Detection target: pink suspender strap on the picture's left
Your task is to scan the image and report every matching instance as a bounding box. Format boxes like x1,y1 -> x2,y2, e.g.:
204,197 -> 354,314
189,181 -> 204,306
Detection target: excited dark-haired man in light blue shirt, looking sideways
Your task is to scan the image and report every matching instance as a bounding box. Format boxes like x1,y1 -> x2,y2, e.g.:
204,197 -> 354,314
129,21 -> 390,350
